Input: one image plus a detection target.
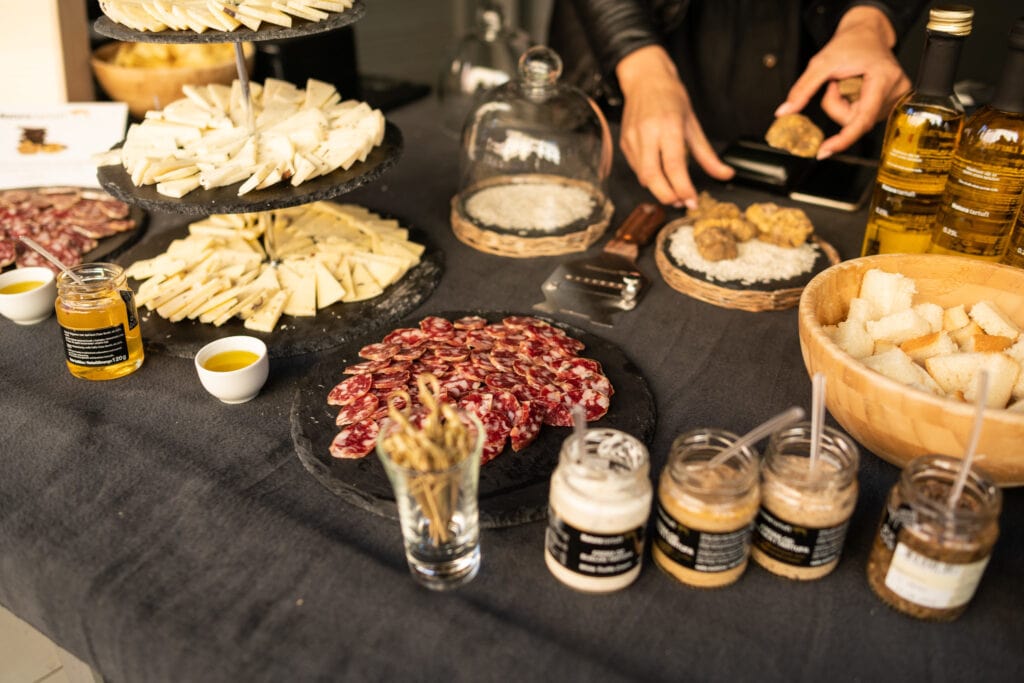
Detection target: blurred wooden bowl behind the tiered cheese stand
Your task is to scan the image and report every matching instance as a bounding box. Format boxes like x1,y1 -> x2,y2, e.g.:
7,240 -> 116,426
91,41 -> 256,119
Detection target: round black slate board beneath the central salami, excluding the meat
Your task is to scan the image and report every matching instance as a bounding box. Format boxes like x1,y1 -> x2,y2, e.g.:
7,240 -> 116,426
291,311 -> 656,528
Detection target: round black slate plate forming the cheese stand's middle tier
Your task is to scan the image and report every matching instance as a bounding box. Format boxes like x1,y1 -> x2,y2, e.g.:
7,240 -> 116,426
97,122 -> 402,216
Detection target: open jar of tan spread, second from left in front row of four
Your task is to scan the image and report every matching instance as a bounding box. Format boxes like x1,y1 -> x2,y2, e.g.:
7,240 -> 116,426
651,429 -> 760,588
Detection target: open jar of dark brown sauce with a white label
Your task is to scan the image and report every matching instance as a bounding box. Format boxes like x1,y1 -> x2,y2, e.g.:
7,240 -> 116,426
867,456 -> 1002,622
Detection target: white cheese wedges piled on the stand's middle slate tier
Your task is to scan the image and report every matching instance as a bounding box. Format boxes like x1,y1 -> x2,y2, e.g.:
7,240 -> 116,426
98,79 -> 385,198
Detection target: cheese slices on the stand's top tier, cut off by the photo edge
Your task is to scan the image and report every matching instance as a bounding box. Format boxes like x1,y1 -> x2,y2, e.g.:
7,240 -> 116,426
99,0 -> 353,33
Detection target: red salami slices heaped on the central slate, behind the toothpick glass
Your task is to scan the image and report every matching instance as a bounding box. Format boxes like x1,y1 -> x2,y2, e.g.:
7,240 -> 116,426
327,315 -> 614,463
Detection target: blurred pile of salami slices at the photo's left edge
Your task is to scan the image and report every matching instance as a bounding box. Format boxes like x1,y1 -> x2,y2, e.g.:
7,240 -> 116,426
0,187 -> 135,271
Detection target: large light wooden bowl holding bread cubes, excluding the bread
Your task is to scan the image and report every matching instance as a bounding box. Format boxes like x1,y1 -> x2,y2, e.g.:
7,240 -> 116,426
799,254 -> 1024,486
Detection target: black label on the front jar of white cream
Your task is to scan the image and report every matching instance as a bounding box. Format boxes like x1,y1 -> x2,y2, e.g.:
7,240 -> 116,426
545,507 -> 643,577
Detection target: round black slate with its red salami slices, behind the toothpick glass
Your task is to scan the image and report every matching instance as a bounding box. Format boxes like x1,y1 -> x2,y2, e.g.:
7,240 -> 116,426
291,311 -> 655,527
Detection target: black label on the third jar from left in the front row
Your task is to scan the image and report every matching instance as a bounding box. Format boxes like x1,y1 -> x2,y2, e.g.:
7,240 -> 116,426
753,507 -> 850,567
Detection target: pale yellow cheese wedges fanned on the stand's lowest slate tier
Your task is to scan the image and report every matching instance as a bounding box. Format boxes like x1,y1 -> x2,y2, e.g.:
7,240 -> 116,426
127,202 -> 424,333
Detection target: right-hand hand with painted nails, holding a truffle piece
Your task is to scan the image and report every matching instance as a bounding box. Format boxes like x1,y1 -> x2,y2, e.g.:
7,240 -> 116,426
775,5 -> 910,159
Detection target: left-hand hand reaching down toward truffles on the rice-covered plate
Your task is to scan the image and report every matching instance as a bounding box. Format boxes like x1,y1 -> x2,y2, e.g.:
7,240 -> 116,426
615,45 -> 734,209
